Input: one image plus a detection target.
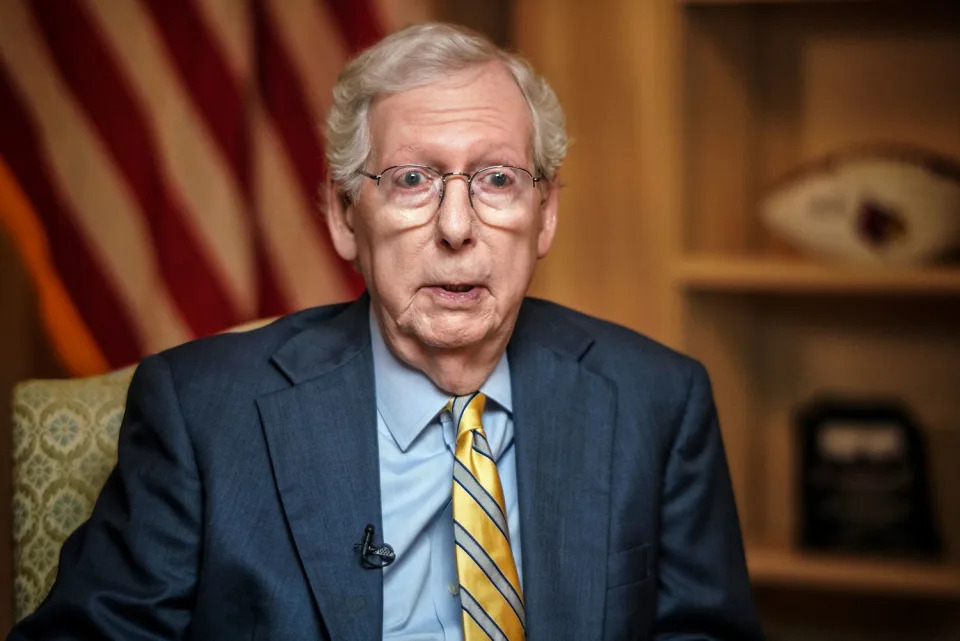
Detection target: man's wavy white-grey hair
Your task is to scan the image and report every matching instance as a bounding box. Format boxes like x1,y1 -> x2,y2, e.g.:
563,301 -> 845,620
324,23 -> 567,199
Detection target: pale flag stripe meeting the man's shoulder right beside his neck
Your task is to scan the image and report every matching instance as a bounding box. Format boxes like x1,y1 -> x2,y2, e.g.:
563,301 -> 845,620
253,105 -> 349,309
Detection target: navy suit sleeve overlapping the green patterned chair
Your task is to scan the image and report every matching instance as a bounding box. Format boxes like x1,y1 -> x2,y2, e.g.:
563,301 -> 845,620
8,356 -> 202,641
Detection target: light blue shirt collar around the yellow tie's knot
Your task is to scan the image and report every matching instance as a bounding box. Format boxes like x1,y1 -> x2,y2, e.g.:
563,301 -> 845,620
370,310 -> 513,452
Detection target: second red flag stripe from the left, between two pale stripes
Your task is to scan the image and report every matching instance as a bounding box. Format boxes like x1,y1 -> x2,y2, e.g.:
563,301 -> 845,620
33,3 -> 237,335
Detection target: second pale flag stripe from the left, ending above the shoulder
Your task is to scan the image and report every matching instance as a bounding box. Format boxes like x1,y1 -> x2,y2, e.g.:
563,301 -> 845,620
90,0 -> 256,318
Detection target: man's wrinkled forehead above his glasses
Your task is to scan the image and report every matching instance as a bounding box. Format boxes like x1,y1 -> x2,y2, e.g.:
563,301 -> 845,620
369,63 -> 533,166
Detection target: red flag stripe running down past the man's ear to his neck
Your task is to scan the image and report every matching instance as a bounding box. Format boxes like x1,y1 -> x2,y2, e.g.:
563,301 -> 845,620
253,0 -> 362,292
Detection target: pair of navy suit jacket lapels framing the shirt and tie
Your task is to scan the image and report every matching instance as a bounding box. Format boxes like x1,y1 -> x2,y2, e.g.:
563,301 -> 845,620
257,295 -> 616,641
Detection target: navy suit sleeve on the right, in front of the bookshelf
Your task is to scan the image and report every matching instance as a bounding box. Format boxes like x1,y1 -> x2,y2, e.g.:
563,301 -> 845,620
656,364 -> 762,641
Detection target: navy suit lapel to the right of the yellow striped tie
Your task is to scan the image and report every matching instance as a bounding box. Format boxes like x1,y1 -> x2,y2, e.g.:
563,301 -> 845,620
509,304 -> 616,640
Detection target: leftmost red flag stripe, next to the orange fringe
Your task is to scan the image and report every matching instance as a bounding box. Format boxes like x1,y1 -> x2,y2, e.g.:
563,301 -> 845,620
0,63 -> 141,367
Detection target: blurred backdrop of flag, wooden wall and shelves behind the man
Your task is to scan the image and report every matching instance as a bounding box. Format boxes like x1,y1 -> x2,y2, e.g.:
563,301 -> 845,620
0,0 -> 960,641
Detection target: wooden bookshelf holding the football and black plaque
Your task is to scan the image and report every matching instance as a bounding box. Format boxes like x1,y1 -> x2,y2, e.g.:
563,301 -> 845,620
661,0 -> 960,639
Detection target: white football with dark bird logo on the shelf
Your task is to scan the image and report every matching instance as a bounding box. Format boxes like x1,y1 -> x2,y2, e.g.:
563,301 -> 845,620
760,147 -> 960,264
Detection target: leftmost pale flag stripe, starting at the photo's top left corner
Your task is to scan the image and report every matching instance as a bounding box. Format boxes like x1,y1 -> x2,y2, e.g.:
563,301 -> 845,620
0,0 -> 190,352
